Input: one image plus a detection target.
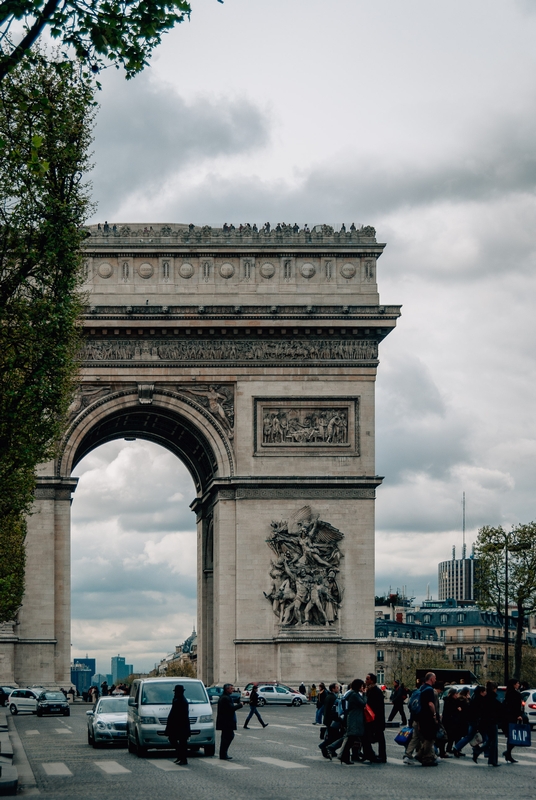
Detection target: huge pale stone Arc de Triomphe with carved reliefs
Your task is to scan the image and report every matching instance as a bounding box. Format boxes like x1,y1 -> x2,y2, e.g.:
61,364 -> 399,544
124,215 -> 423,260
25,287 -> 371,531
1,224 -> 400,685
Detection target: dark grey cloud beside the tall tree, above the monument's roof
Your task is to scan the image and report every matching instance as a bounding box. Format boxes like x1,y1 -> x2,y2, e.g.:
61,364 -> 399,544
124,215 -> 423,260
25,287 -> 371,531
92,71 -> 269,216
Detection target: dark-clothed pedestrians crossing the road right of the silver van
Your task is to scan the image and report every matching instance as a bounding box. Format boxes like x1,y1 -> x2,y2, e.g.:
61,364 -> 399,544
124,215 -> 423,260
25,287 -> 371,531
216,672 -> 524,767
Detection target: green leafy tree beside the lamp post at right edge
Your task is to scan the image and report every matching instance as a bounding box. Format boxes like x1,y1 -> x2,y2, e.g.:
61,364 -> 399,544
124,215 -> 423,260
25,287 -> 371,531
475,522 -> 536,678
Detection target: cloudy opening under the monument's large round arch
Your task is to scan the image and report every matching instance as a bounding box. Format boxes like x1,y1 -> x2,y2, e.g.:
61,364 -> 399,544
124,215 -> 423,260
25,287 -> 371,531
71,438 -> 198,675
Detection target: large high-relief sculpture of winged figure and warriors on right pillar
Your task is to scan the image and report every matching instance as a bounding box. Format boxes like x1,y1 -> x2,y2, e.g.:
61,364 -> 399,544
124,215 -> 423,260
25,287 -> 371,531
263,506 -> 344,629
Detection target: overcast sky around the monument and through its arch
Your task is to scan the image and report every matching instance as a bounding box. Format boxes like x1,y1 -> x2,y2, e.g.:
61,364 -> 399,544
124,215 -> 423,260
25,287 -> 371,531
73,0 -> 536,671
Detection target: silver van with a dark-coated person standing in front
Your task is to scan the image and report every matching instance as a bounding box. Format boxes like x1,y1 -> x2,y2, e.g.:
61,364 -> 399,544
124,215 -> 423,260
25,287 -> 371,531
127,678 -> 216,756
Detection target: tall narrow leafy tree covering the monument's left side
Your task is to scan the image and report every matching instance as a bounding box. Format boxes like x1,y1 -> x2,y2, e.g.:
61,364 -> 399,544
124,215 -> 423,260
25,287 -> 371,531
0,53 -> 94,621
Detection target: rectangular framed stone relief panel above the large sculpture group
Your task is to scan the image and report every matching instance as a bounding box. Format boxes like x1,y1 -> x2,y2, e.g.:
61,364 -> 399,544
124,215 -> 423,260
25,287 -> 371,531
253,397 -> 359,456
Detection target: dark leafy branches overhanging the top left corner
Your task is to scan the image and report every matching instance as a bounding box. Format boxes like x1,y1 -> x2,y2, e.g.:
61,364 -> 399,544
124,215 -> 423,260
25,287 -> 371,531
0,0 -> 191,81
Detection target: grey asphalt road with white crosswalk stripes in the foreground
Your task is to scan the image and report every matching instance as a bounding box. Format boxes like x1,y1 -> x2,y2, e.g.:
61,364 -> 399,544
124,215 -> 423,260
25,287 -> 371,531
8,704 -> 536,800
